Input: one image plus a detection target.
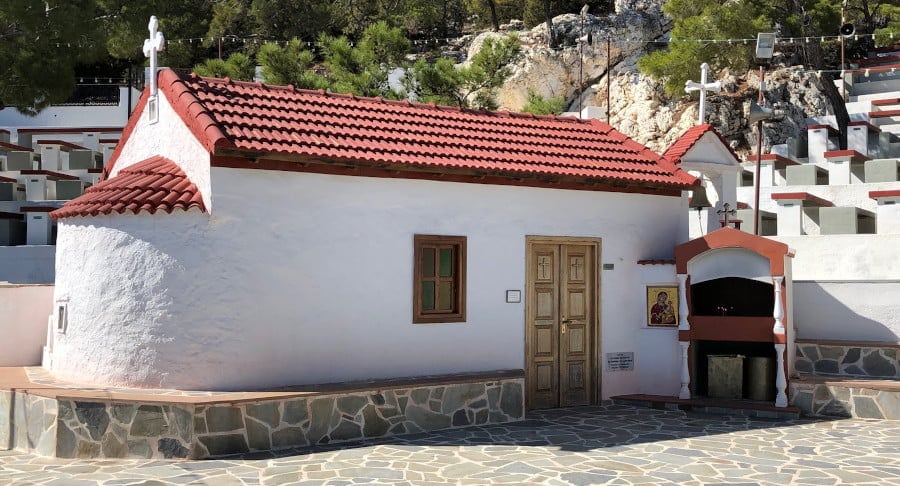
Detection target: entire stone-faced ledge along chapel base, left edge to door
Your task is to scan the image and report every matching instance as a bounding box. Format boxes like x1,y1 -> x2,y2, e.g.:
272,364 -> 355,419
0,378 -> 525,459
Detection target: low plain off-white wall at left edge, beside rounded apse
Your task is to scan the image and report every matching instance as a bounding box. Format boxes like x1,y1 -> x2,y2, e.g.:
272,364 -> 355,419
0,283 -> 53,366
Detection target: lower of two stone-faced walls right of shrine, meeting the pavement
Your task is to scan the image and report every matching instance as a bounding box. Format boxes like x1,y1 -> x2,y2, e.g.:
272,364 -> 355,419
791,382 -> 900,420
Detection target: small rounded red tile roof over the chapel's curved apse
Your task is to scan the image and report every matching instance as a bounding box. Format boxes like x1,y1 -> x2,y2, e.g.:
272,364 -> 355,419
50,156 -> 206,219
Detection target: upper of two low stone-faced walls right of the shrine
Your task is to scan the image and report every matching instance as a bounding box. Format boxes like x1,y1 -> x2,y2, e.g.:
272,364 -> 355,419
794,342 -> 900,379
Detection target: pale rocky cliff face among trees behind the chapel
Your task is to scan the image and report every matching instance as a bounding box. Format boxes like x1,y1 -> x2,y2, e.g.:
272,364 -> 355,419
468,10 -> 832,154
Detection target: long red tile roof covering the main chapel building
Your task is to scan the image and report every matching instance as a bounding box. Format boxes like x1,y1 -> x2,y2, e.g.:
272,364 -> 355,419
103,70 -> 695,190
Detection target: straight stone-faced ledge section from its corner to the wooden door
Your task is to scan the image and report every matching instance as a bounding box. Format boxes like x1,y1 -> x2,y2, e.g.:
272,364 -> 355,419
192,379 -> 525,457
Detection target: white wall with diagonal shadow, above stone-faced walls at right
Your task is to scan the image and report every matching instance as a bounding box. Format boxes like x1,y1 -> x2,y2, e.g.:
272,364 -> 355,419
794,281 -> 900,343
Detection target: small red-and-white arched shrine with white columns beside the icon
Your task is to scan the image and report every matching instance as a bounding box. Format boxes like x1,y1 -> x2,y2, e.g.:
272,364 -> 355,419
675,227 -> 795,408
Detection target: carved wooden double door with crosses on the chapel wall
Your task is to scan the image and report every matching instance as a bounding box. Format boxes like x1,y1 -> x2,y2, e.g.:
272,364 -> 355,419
525,242 -> 597,409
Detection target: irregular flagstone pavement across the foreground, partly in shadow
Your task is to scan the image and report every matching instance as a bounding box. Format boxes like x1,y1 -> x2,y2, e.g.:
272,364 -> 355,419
0,404 -> 900,486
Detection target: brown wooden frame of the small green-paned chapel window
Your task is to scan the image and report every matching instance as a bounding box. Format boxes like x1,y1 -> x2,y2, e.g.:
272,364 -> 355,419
413,235 -> 466,324
